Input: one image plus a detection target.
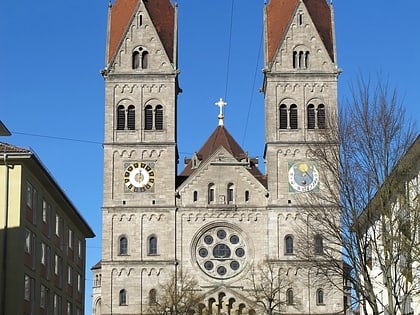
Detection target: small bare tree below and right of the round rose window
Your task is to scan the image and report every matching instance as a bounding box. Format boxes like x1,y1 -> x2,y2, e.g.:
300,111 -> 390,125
244,259 -> 291,315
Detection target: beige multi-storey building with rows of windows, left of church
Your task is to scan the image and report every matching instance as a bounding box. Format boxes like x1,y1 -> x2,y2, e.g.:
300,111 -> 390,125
0,142 -> 95,315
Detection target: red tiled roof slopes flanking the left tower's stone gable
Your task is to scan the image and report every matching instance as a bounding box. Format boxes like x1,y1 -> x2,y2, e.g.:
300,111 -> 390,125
107,0 -> 175,63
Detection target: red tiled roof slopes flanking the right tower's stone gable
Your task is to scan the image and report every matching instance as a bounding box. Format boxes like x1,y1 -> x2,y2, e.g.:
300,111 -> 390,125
266,0 -> 334,62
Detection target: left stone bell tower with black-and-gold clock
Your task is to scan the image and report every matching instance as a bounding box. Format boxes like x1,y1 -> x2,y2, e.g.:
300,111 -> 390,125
101,0 -> 180,314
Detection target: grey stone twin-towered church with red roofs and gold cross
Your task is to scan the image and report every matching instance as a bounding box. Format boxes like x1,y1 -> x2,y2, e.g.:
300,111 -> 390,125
92,0 -> 347,315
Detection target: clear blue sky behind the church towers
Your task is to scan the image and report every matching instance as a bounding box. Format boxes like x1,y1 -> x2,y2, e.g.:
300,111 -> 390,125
0,0 -> 420,314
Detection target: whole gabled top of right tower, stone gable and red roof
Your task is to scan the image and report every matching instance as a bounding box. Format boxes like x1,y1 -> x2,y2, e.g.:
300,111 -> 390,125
266,0 -> 335,71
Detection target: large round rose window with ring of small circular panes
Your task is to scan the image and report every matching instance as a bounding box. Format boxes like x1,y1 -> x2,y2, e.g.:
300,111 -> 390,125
193,226 -> 247,279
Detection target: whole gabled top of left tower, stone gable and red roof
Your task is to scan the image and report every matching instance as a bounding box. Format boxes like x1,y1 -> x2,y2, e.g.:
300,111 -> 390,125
107,0 -> 175,73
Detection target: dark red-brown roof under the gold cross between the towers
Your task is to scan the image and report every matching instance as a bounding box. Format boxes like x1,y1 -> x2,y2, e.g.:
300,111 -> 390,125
180,125 -> 265,184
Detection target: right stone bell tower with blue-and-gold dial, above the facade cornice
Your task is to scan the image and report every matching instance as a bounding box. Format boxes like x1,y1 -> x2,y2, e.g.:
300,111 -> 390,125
263,0 -> 339,207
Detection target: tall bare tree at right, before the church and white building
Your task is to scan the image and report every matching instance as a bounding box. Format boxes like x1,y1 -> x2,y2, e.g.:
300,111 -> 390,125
300,79 -> 420,314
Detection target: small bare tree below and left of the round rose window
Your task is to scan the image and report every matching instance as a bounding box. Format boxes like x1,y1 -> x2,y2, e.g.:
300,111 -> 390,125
147,270 -> 208,315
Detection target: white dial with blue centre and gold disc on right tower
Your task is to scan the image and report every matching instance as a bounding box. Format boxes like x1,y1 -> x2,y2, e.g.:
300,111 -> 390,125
289,161 -> 319,192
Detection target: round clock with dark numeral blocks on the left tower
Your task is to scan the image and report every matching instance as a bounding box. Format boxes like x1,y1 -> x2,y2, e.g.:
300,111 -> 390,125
124,162 -> 155,192
